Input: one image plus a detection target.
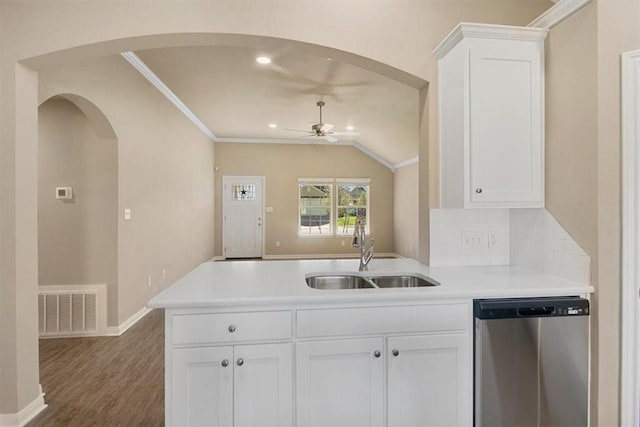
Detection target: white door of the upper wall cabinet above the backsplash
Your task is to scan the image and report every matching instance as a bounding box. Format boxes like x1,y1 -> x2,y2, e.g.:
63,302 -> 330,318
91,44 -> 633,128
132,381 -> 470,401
465,43 -> 544,207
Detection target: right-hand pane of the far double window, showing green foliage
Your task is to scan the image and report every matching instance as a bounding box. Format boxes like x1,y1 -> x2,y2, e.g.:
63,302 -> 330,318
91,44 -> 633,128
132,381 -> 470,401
336,184 -> 369,234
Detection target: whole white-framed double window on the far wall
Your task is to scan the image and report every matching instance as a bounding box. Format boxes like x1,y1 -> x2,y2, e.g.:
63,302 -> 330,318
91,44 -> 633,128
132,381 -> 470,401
298,178 -> 370,237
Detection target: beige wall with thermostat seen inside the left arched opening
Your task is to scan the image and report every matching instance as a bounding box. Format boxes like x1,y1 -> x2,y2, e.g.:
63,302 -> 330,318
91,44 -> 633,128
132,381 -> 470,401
38,97 -> 118,324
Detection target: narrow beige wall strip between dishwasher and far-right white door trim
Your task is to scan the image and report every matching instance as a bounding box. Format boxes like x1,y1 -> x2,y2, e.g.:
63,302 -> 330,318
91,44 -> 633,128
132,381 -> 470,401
595,0 -> 640,426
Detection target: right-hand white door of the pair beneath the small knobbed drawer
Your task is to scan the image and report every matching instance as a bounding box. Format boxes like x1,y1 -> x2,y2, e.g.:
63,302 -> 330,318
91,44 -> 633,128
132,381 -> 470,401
233,343 -> 293,427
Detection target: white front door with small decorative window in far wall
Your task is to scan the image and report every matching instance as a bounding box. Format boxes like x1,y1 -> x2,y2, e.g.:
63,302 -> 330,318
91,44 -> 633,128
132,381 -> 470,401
222,176 -> 264,258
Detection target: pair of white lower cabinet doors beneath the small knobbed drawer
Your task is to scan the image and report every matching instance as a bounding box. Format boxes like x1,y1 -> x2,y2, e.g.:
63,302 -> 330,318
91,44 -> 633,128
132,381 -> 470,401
167,343 -> 293,427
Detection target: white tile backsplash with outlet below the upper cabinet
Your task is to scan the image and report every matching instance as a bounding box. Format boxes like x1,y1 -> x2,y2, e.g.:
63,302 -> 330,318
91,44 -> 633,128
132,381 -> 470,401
430,209 -> 591,283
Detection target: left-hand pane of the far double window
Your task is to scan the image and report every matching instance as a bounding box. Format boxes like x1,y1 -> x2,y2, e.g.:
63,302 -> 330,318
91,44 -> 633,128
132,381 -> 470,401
298,183 -> 332,236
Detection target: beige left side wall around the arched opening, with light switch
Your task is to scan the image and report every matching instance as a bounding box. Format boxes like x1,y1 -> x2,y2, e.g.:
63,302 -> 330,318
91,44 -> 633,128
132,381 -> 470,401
39,55 -> 214,326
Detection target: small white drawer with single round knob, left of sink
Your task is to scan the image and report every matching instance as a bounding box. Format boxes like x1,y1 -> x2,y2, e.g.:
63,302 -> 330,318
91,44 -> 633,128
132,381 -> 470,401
171,311 -> 292,345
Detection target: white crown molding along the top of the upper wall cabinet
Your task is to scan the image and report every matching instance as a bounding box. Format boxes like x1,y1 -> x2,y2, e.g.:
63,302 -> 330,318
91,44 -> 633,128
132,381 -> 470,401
433,22 -> 548,59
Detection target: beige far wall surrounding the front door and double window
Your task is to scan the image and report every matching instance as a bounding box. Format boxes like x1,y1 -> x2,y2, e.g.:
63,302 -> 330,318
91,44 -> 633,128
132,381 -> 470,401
215,143 -> 393,256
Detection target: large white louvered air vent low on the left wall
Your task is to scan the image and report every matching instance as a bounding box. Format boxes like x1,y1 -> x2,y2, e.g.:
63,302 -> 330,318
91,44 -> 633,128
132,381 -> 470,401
38,285 -> 106,338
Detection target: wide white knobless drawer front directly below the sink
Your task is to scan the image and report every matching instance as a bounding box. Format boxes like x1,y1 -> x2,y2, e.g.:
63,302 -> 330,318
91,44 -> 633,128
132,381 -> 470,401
297,304 -> 471,338
